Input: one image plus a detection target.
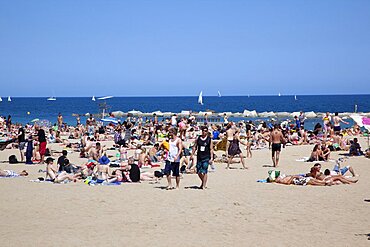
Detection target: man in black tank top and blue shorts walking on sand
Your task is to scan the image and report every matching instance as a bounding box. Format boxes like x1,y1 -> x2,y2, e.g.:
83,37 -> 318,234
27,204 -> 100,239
190,126 -> 213,190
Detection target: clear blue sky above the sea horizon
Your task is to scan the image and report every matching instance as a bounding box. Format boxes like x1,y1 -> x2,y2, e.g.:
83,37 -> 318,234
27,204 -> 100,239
0,0 -> 370,97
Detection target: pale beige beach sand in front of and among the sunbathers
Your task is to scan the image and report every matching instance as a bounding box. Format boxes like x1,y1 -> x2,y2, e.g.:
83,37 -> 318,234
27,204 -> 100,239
0,138 -> 370,246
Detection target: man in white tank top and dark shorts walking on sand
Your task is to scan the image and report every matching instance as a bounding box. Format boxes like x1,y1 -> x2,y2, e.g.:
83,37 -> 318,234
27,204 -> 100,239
164,128 -> 183,190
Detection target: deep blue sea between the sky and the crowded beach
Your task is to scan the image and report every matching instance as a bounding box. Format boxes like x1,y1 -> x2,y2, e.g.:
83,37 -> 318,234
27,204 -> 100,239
0,94 -> 370,129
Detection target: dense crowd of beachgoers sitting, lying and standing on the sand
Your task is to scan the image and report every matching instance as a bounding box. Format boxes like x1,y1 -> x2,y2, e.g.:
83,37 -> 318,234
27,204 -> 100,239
0,112 -> 369,190
